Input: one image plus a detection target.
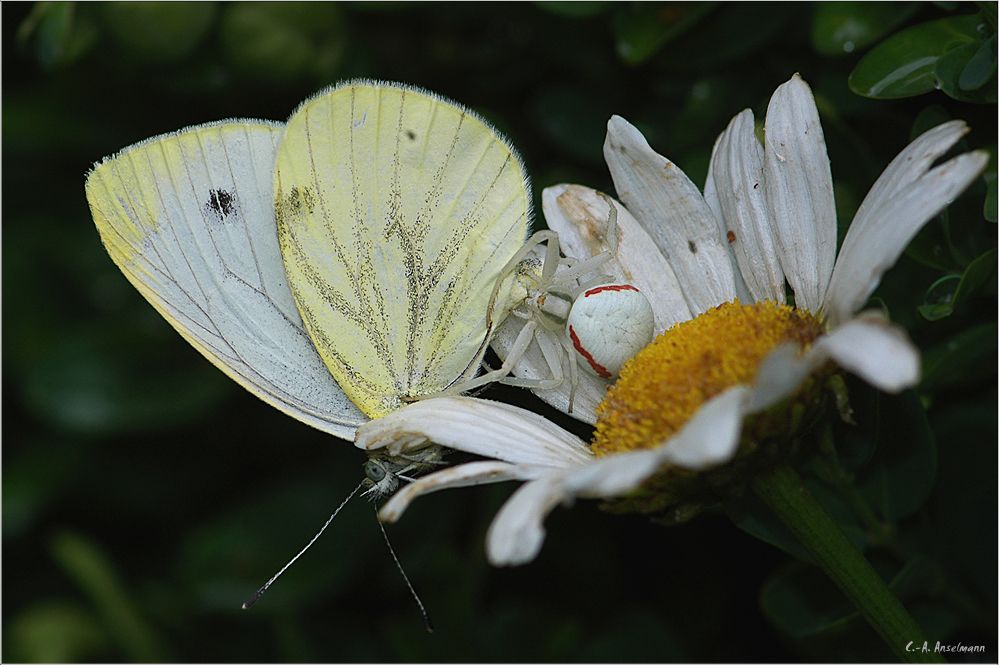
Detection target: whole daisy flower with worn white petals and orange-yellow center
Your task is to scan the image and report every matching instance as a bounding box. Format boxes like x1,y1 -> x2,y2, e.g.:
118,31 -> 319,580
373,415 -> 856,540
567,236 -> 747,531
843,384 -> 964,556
356,75 -> 988,565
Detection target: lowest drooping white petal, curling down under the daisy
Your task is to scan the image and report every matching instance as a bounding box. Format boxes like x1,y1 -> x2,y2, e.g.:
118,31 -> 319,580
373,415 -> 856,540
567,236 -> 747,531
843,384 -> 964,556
486,473 -> 565,566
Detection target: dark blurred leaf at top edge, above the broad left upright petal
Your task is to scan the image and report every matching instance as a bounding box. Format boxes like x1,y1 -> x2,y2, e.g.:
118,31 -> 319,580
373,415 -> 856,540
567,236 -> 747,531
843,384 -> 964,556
614,2 -> 716,65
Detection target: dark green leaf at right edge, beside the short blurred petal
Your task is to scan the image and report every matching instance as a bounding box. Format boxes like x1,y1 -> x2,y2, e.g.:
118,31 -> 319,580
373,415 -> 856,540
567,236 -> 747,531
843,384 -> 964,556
919,323 -> 999,392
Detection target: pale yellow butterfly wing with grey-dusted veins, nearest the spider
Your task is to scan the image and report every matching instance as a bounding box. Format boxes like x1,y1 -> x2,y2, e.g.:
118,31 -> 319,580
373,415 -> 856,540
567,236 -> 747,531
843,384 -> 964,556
275,82 -> 530,416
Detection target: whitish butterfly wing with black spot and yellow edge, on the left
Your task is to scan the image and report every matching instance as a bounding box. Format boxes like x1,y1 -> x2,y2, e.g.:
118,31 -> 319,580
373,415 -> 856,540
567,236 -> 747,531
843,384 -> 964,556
86,121 -> 367,438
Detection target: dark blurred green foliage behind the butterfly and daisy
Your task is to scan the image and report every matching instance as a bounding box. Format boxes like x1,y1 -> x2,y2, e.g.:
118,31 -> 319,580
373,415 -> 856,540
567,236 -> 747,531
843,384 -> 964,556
2,2 -> 997,662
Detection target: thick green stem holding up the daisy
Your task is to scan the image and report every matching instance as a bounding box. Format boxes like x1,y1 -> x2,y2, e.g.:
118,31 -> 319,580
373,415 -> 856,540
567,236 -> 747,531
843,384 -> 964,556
753,466 -> 946,663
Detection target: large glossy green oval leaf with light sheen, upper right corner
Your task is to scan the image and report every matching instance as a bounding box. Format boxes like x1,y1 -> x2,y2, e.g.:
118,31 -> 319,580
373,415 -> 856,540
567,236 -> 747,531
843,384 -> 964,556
849,14 -> 983,99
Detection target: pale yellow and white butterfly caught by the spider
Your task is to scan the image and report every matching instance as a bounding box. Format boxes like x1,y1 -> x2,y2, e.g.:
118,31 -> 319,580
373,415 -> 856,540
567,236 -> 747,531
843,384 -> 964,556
86,81 -> 530,494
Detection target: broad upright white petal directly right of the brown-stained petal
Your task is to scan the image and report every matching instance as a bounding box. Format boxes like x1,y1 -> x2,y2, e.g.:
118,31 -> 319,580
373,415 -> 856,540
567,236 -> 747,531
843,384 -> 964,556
604,116 -> 735,314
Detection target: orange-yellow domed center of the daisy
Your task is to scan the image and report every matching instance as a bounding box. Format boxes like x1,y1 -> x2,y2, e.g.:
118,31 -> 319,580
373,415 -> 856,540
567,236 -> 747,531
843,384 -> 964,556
591,300 -> 821,455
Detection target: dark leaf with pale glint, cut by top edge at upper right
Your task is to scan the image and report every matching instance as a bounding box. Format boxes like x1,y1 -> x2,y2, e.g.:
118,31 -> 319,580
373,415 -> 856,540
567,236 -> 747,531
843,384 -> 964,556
812,2 -> 919,55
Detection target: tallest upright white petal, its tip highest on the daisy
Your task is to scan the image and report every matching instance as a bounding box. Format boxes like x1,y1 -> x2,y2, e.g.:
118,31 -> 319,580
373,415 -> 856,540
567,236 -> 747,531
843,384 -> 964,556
764,74 -> 836,312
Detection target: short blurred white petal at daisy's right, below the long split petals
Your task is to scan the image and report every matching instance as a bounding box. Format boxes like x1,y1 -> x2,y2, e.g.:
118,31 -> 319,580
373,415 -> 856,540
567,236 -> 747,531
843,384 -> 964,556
810,311 -> 920,393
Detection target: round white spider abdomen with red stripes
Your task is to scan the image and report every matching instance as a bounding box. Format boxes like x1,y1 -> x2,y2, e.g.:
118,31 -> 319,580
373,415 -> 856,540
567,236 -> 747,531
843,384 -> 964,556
566,284 -> 655,379
